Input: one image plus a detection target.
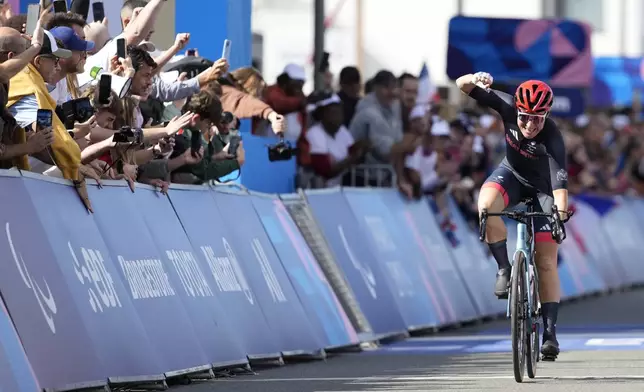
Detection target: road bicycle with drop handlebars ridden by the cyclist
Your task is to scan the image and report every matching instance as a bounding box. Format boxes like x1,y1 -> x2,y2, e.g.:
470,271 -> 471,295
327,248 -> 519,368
479,197 -> 572,382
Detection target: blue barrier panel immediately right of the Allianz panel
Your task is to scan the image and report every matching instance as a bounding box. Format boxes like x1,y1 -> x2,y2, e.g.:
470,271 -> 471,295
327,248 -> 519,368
212,191 -> 324,355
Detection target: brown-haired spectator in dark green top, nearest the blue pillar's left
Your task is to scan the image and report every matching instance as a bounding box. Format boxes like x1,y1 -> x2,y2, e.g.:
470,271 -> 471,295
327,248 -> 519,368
168,90 -> 245,184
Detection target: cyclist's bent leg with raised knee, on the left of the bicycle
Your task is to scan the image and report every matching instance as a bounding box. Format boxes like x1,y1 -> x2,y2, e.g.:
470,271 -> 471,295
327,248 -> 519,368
478,166 -> 520,298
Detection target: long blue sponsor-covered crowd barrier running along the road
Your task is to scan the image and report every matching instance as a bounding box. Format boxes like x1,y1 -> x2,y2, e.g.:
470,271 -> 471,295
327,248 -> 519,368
0,170 -> 644,392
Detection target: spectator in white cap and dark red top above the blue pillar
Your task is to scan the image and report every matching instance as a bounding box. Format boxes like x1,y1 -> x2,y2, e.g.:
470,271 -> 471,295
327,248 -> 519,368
264,64 -> 306,140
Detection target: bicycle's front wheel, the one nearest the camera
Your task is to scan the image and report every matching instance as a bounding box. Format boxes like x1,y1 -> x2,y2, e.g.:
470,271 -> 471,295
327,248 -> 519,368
510,252 -> 527,382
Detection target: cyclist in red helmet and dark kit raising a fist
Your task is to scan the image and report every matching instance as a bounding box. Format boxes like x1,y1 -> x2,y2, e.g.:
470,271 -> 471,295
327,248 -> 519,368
456,72 -> 568,358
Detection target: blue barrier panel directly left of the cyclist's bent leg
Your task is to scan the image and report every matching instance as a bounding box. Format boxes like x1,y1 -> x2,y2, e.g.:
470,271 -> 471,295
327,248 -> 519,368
449,198 -> 506,316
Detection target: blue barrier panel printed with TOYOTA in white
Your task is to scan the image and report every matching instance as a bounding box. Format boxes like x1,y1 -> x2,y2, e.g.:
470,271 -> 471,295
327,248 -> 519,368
135,189 -> 247,367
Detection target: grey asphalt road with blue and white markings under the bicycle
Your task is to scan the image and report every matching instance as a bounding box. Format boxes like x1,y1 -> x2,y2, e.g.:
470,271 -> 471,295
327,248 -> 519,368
170,290 -> 644,392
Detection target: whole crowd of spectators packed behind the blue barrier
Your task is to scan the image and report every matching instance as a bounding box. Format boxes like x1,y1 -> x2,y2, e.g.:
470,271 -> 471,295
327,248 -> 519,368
0,0 -> 644,217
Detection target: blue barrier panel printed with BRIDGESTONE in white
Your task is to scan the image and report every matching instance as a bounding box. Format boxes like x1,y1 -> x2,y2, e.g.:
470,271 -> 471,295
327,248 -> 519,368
88,184 -> 208,373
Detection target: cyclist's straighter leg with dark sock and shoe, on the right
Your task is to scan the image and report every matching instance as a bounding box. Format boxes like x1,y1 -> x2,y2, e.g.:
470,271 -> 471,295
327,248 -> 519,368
534,194 -> 561,357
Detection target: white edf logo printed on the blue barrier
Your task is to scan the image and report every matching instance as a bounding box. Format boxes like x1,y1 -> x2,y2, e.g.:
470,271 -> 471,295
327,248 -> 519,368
67,242 -> 123,313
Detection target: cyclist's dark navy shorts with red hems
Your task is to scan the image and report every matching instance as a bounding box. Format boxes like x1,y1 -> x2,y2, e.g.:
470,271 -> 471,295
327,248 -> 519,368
483,165 -> 556,243
